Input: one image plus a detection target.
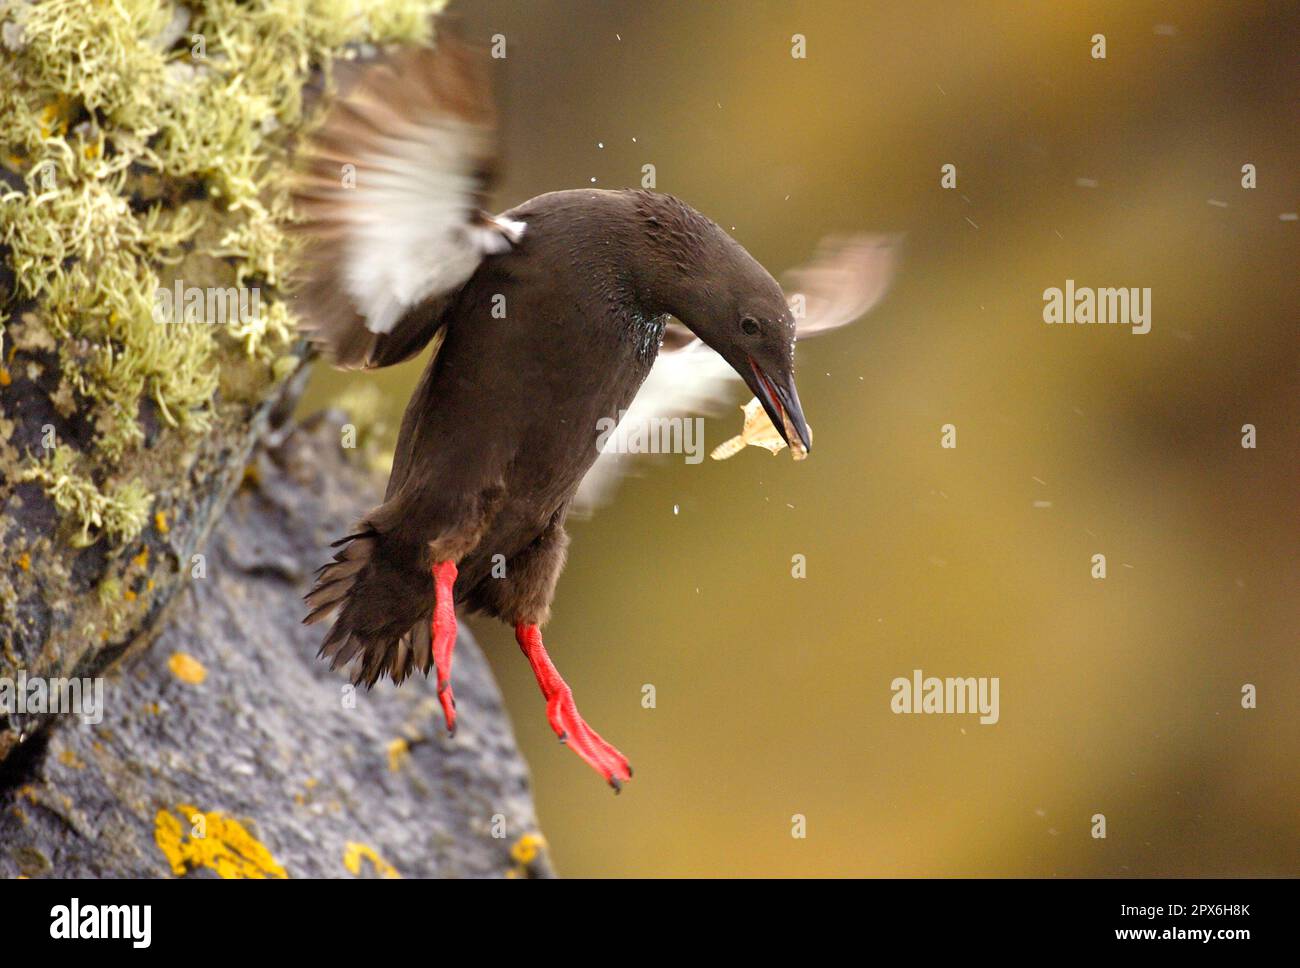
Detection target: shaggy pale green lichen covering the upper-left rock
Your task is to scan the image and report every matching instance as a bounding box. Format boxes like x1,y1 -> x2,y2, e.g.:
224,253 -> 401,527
0,0 -> 442,542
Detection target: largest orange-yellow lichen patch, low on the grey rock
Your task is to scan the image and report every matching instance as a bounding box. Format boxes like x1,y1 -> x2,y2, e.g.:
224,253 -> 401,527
153,803 -> 289,880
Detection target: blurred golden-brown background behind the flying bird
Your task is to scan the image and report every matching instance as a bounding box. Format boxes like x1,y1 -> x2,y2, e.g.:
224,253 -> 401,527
304,0 -> 1300,876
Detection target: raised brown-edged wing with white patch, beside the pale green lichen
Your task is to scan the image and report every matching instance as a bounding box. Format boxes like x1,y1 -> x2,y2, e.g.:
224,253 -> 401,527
293,39 -> 524,368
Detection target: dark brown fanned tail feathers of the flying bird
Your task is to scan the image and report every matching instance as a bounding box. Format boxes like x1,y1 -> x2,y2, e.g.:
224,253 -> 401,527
303,522 -> 433,689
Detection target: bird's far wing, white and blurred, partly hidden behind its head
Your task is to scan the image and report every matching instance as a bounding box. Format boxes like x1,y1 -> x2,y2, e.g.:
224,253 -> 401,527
573,235 -> 901,515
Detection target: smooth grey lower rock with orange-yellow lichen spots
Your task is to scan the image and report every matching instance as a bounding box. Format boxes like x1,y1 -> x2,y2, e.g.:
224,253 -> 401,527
0,420 -> 550,877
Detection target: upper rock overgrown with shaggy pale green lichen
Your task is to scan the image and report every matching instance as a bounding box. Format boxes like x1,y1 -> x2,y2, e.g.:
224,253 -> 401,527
0,0 -> 442,763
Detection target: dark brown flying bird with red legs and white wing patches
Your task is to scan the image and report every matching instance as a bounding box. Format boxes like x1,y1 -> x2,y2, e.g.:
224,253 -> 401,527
293,39 -> 894,790
